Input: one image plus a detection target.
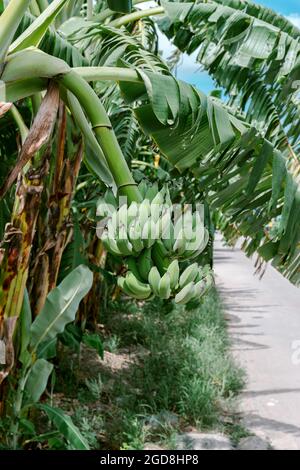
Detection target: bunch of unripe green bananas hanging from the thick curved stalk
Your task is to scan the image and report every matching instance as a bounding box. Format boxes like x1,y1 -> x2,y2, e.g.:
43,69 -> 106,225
98,183 -> 213,304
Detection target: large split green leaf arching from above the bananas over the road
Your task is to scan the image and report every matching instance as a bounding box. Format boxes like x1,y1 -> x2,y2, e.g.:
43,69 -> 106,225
120,66 -> 300,284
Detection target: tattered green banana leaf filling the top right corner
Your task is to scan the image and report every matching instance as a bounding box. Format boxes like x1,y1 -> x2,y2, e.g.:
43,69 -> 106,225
159,0 -> 300,158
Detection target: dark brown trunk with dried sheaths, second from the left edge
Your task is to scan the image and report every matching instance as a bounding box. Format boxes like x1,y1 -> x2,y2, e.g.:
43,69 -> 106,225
30,111 -> 83,316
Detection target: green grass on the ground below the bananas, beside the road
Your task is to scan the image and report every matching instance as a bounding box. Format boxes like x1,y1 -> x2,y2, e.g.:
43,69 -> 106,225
55,291 -> 244,450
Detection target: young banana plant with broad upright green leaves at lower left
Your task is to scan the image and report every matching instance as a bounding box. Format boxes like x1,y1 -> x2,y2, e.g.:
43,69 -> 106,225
6,266 -> 93,450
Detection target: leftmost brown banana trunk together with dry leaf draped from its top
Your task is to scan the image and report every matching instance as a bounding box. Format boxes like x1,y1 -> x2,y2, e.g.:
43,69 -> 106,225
0,84 -> 59,396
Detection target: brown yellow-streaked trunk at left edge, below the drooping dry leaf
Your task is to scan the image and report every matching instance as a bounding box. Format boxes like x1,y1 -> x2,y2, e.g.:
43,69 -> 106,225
0,172 -> 43,392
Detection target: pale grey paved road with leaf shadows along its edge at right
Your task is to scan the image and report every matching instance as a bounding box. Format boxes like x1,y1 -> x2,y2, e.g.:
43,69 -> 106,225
215,234 -> 300,450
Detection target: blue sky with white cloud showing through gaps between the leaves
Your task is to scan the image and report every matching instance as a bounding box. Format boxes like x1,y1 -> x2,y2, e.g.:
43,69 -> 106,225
156,0 -> 300,93
